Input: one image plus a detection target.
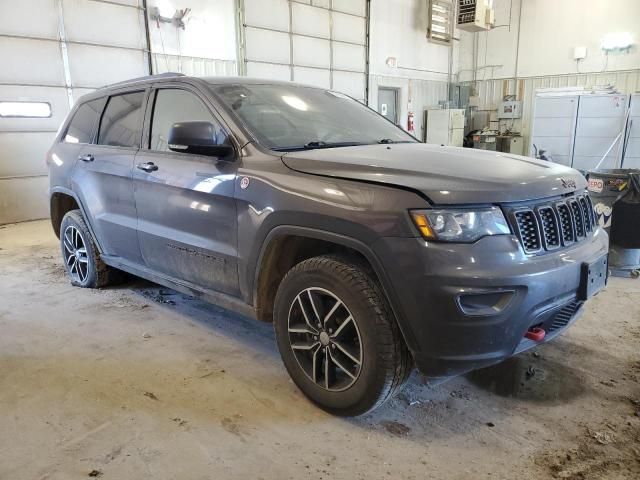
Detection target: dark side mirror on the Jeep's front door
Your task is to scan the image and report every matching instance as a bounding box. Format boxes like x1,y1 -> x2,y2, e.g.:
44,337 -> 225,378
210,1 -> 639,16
167,122 -> 233,159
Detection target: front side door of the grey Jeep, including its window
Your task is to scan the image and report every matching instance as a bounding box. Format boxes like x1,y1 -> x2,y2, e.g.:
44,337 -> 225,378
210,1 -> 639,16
133,85 -> 239,295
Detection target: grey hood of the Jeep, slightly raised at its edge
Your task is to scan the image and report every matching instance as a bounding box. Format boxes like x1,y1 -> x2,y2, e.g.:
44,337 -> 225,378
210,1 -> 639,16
282,143 -> 587,204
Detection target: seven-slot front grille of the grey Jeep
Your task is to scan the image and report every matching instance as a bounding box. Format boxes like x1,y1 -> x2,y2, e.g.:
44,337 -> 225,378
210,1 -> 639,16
509,194 -> 596,254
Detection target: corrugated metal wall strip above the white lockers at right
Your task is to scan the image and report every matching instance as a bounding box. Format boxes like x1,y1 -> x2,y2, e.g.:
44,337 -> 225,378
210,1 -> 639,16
467,69 -> 640,151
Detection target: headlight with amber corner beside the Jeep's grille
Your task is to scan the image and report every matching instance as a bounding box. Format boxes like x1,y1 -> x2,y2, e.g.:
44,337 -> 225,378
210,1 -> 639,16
410,207 -> 511,242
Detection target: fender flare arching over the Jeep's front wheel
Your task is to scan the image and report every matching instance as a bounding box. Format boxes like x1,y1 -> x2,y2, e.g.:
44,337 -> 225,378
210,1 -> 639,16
250,225 -> 417,351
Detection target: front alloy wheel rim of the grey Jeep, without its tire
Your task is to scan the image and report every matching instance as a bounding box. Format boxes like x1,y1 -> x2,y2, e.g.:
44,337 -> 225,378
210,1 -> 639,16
288,287 -> 362,391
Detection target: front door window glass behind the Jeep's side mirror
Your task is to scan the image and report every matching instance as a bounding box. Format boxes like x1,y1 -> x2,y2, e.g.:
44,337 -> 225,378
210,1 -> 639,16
149,89 -> 228,152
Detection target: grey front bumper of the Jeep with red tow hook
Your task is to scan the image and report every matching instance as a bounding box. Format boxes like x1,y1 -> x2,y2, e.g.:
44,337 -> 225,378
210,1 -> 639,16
373,229 -> 608,378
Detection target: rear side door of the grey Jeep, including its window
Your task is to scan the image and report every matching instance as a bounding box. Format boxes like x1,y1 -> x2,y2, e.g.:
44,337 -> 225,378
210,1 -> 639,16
73,90 -> 147,264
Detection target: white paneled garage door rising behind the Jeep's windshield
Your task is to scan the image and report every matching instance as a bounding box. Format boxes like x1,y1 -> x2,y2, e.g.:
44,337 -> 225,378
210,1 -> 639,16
241,0 -> 368,102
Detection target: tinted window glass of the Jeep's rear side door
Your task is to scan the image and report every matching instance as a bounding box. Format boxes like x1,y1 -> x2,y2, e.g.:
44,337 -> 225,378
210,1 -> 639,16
98,92 -> 144,147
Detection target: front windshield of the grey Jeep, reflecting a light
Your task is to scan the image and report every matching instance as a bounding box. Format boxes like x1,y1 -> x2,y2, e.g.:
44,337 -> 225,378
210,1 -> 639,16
214,85 -> 416,151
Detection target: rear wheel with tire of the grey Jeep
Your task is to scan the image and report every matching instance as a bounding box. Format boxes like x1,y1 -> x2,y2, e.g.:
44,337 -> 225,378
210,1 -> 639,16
60,210 -> 124,288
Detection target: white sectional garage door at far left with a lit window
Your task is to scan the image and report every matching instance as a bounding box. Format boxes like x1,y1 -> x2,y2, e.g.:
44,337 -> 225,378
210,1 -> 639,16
0,0 -> 149,224
